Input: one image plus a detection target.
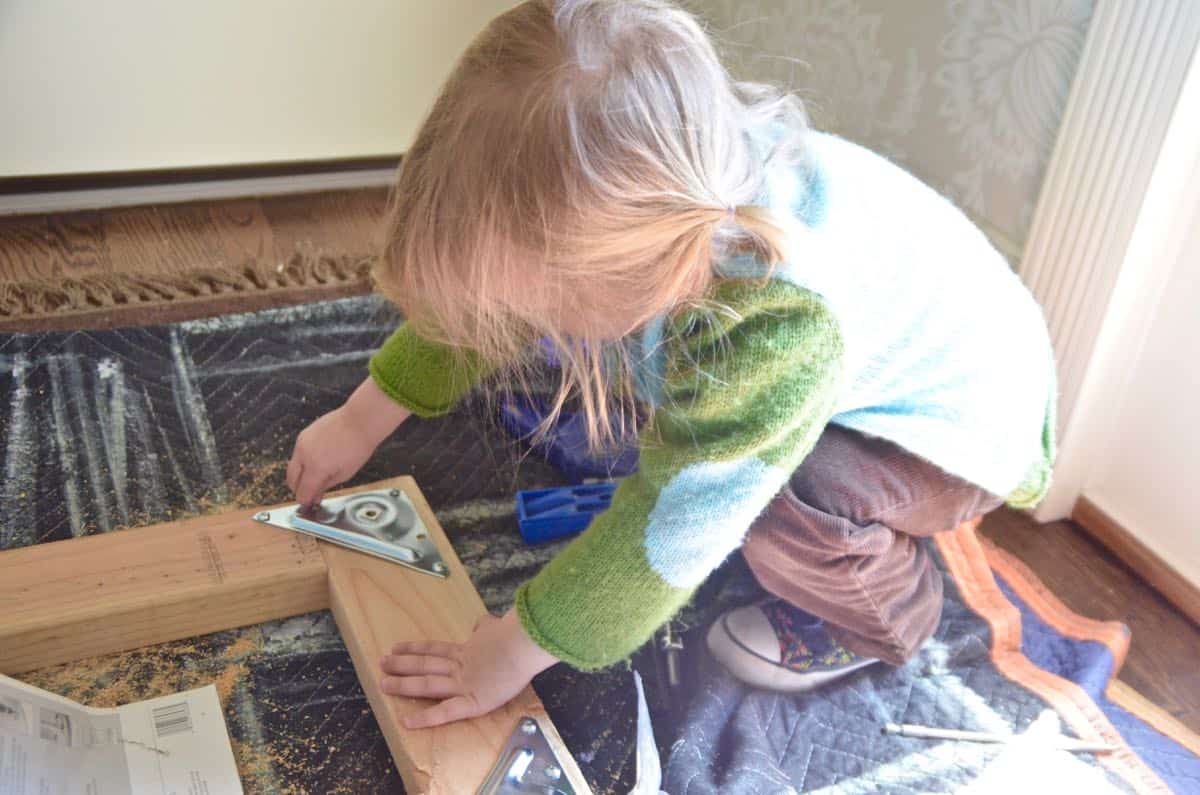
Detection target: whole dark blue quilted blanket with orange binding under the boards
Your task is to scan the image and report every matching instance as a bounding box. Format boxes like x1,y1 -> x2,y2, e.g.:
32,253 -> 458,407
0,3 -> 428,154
0,297 -> 1200,795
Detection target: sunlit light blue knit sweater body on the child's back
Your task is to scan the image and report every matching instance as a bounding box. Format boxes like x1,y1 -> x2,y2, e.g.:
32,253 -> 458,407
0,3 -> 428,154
722,132 -> 1056,504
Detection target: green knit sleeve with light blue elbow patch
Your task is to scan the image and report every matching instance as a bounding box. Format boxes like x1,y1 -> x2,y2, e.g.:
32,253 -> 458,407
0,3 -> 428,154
516,281 -> 842,669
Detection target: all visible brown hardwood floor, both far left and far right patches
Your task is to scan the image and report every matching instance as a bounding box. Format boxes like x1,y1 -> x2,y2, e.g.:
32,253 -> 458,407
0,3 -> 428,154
0,184 -> 1200,731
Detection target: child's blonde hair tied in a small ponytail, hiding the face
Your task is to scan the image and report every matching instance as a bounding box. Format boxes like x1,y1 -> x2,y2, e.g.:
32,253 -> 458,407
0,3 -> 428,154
376,0 -> 804,447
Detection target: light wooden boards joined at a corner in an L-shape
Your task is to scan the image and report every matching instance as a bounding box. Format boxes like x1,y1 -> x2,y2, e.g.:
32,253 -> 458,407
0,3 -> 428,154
0,478 -> 590,795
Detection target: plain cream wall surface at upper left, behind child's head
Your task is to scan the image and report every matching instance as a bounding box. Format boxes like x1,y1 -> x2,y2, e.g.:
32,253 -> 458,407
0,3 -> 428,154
0,0 -> 510,177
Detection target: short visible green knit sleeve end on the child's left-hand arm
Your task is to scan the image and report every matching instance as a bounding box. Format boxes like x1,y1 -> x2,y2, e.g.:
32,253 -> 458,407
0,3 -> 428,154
368,324 -> 487,418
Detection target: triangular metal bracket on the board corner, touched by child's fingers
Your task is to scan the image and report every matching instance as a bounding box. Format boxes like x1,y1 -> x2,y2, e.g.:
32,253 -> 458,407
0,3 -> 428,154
254,489 -> 450,578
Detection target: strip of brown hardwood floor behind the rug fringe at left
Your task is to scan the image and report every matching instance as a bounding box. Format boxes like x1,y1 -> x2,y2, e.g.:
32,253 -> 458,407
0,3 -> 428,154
0,189 -> 386,281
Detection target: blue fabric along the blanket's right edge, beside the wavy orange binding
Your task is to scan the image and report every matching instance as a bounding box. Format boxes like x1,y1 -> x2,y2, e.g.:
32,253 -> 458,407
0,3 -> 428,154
996,575 -> 1200,793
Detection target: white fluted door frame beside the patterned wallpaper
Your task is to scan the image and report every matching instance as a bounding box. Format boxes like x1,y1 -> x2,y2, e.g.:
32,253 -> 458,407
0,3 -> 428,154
1020,0 -> 1200,521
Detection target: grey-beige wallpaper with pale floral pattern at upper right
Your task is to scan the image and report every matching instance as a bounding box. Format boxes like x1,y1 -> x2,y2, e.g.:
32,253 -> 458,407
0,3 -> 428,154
689,0 -> 1096,258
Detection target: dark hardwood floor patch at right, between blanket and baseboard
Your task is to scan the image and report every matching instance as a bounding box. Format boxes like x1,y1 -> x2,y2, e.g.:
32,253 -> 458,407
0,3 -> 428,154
982,509 -> 1200,731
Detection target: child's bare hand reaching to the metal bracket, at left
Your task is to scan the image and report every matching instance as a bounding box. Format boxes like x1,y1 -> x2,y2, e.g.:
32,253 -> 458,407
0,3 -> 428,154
288,378 -> 409,506
